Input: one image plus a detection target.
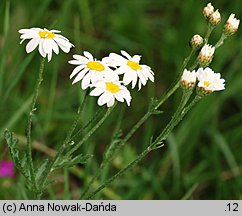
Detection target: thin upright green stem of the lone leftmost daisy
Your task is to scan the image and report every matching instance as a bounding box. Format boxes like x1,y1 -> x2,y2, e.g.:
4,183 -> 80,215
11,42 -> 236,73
27,58 -> 45,189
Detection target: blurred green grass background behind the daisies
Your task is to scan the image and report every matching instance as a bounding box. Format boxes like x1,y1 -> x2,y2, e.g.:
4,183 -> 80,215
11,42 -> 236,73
0,0 -> 242,199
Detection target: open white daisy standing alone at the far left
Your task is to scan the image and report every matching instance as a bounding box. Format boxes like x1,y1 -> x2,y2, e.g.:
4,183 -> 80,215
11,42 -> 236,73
18,28 -> 74,62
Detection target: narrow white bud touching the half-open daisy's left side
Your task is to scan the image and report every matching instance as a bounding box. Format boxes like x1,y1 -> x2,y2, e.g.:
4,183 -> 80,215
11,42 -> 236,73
181,69 -> 197,90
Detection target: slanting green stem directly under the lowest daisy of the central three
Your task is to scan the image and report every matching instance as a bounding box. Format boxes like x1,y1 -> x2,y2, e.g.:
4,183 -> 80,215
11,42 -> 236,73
64,103 -> 116,158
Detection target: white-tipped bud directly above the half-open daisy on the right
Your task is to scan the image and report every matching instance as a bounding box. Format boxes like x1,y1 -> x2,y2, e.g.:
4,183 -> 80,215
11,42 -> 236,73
198,44 -> 215,67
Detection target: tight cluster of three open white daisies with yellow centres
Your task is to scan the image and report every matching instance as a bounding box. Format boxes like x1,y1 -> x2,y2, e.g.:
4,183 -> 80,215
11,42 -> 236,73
69,51 -> 154,107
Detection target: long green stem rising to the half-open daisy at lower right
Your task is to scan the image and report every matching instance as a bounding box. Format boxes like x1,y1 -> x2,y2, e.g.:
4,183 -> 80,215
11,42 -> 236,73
87,96 -> 201,199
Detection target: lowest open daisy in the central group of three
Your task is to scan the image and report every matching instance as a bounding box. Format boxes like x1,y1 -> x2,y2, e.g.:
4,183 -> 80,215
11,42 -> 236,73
90,79 -> 131,107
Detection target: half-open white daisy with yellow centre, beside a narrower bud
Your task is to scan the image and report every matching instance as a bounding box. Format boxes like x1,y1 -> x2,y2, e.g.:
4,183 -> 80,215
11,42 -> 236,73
197,67 -> 225,93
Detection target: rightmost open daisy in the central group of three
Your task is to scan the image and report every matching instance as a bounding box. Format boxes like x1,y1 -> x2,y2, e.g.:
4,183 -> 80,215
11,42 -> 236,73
105,50 -> 154,90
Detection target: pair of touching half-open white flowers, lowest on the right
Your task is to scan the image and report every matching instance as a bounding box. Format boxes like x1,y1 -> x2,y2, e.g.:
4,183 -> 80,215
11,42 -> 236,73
181,67 -> 225,96
